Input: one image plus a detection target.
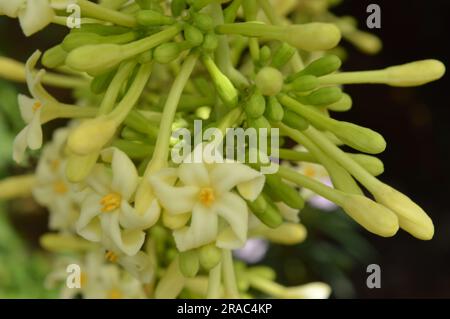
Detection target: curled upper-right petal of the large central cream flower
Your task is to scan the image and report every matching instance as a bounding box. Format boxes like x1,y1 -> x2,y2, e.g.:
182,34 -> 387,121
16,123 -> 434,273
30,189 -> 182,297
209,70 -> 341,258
210,162 -> 265,200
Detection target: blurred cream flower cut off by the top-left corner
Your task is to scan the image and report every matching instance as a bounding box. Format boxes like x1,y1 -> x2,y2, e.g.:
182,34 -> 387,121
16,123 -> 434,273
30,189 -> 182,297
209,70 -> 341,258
0,0 -> 55,37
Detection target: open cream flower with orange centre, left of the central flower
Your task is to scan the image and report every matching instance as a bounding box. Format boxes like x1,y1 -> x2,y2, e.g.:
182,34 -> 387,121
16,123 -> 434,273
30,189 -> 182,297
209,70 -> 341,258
76,148 -> 159,256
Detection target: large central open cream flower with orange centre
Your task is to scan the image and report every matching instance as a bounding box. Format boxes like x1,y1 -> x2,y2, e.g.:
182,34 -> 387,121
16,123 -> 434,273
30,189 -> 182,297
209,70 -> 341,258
150,148 -> 265,251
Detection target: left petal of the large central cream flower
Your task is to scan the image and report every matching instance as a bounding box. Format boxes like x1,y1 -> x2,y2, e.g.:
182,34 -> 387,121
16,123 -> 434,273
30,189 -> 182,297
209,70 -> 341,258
149,170 -> 199,214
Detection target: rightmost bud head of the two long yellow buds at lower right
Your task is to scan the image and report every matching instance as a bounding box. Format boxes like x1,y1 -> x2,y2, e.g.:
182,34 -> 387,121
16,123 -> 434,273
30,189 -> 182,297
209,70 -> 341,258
372,184 -> 434,240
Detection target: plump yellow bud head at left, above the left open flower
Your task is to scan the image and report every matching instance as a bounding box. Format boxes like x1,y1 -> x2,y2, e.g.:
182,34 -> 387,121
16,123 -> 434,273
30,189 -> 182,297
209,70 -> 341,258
67,117 -> 117,155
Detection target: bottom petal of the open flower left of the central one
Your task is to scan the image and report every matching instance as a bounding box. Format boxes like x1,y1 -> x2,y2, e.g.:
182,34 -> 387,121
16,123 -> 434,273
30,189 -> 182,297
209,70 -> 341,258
100,210 -> 145,256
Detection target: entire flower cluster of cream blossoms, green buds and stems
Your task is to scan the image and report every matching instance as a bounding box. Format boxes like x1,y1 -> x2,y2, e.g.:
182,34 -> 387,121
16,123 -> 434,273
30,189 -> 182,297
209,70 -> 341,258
0,0 -> 445,298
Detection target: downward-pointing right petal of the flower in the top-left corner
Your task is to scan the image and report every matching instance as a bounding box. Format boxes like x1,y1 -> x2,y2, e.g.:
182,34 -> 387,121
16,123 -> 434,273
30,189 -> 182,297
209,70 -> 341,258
19,0 -> 55,36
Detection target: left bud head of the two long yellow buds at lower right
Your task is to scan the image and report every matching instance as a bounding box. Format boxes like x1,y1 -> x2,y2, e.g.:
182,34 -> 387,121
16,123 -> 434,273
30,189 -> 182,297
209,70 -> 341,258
342,194 -> 399,237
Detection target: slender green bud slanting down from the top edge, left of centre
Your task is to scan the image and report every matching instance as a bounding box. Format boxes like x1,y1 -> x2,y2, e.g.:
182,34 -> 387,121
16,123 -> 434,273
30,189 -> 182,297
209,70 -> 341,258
77,0 -> 136,27
